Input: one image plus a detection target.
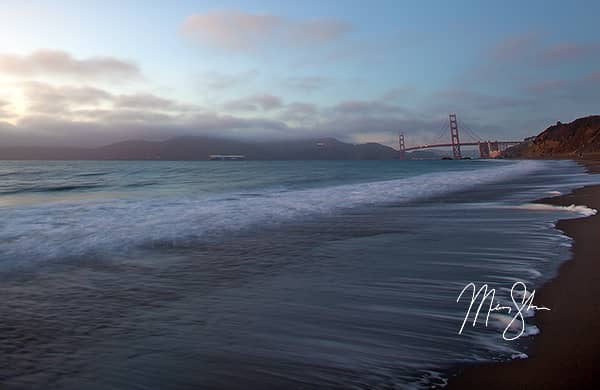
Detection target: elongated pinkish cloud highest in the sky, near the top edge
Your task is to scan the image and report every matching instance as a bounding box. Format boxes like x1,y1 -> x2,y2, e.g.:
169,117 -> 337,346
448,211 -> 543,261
181,10 -> 352,51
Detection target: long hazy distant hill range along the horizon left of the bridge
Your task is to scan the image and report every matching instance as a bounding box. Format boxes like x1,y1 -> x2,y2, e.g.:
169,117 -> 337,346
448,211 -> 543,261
0,136 -> 398,160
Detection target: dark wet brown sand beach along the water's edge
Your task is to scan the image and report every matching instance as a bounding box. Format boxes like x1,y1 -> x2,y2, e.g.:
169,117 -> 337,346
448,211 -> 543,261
448,161 -> 600,389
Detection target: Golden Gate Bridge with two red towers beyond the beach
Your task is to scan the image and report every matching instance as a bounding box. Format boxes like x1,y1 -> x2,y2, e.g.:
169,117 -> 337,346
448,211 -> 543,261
398,113 -> 523,160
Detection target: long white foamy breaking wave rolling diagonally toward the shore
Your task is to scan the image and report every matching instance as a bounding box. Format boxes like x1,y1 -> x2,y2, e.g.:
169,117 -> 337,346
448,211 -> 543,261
0,161 -> 543,261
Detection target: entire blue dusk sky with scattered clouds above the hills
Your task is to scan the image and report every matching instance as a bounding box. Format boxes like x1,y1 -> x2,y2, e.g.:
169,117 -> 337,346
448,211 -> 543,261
0,0 -> 600,146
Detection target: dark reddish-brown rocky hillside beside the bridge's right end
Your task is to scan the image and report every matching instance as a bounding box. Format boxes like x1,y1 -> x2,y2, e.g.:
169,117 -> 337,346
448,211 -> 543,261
504,115 -> 600,158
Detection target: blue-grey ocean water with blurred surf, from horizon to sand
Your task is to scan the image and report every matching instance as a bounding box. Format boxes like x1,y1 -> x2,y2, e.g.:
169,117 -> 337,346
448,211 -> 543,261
0,160 -> 598,389
